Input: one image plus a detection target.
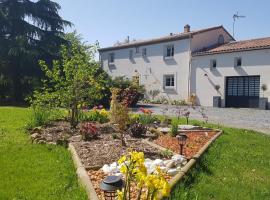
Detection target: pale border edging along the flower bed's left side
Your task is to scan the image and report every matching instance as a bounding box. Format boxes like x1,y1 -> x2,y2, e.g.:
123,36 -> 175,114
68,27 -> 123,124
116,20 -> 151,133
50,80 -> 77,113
68,143 -> 99,200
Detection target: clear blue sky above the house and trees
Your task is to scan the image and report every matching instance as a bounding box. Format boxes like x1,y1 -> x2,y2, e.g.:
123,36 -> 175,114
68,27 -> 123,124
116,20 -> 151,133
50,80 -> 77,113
55,0 -> 270,47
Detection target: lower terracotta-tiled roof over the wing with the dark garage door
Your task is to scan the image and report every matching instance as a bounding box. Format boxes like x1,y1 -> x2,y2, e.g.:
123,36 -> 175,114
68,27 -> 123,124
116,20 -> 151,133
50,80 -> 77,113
193,37 -> 270,56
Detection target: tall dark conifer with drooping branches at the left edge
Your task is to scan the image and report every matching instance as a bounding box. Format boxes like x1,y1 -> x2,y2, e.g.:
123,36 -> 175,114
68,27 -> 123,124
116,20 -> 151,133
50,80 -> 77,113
0,0 -> 71,102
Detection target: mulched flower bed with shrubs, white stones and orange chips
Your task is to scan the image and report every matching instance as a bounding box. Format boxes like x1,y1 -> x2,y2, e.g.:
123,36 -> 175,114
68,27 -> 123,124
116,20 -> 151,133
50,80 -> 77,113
27,103 -> 219,199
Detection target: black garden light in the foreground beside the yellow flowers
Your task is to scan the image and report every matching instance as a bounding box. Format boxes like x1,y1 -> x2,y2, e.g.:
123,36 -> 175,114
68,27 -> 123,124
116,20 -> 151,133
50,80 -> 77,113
100,176 -> 124,200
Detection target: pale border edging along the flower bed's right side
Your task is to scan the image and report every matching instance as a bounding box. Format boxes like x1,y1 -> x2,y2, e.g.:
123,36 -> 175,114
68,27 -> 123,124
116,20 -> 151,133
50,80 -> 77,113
158,130 -> 222,199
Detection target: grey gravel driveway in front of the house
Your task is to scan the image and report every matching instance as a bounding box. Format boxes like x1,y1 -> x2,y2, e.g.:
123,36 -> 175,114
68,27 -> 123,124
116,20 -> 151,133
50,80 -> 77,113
133,104 -> 270,135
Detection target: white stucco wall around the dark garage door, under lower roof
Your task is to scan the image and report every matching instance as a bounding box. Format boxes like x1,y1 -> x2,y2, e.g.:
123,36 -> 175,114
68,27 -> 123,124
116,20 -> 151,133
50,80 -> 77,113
191,49 -> 270,106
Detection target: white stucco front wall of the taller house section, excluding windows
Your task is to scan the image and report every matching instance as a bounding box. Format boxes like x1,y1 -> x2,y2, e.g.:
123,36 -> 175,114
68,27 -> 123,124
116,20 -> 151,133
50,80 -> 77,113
100,39 -> 190,100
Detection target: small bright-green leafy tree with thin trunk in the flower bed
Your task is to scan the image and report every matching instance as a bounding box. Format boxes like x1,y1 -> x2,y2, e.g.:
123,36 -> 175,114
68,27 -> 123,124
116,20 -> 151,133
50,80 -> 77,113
32,33 -> 108,128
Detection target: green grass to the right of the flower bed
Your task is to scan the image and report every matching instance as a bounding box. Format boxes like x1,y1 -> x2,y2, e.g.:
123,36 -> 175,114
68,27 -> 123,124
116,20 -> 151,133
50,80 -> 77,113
169,120 -> 270,200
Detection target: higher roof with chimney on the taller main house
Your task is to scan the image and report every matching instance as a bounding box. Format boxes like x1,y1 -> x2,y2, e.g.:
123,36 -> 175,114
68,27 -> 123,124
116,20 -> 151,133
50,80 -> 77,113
99,26 -> 234,52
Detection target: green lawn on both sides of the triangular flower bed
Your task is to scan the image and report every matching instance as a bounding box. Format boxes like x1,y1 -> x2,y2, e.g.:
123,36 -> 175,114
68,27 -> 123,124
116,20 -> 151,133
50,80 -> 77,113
0,107 -> 270,200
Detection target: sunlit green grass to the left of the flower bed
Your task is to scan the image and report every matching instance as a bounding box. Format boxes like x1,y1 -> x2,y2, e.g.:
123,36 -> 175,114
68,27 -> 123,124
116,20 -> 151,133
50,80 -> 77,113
0,107 -> 87,200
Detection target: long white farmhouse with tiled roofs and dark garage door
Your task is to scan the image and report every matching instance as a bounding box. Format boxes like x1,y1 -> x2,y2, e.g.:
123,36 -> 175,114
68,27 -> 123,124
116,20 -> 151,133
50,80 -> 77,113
99,25 -> 270,108
